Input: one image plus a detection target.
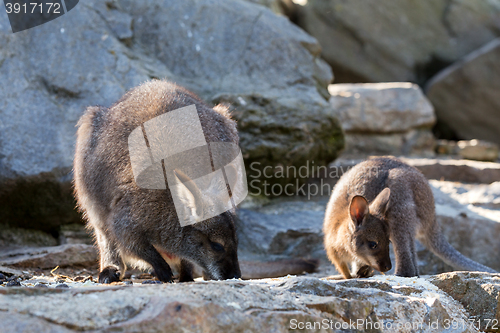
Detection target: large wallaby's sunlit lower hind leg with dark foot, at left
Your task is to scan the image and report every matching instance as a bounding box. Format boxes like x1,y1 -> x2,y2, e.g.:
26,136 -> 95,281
94,228 -> 125,283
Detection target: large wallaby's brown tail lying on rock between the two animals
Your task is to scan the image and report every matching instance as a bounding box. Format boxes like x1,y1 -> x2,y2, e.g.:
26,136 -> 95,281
240,259 -> 319,280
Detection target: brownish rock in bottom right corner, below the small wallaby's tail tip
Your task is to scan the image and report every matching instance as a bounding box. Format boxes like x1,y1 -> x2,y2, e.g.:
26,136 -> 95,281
429,272 -> 500,332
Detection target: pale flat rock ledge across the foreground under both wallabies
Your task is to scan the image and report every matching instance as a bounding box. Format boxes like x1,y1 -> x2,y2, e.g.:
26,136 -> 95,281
0,272 -> 500,332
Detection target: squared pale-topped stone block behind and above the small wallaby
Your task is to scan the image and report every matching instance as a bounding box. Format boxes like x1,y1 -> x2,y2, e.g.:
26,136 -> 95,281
328,82 -> 436,156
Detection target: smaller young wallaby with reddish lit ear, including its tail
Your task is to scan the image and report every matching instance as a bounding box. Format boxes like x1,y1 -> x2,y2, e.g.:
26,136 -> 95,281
323,158 -> 496,279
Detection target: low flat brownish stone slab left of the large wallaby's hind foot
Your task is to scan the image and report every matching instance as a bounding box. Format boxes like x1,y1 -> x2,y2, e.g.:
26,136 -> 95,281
0,244 -> 97,269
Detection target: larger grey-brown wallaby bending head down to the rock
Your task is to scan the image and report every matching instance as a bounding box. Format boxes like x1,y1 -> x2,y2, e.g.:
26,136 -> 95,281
74,80 -> 241,283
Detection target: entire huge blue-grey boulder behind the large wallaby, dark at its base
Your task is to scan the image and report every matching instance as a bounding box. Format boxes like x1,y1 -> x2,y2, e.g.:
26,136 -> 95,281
0,0 -> 343,230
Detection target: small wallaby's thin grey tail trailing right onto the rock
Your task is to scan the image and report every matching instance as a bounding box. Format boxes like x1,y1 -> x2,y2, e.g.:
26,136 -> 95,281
423,232 -> 498,273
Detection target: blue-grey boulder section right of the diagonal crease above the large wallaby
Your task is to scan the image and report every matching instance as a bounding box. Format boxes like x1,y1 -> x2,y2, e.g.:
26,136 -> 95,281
119,0 -> 343,176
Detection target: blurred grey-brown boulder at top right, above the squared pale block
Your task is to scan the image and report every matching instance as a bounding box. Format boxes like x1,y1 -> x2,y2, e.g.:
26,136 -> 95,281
299,0 -> 500,82
